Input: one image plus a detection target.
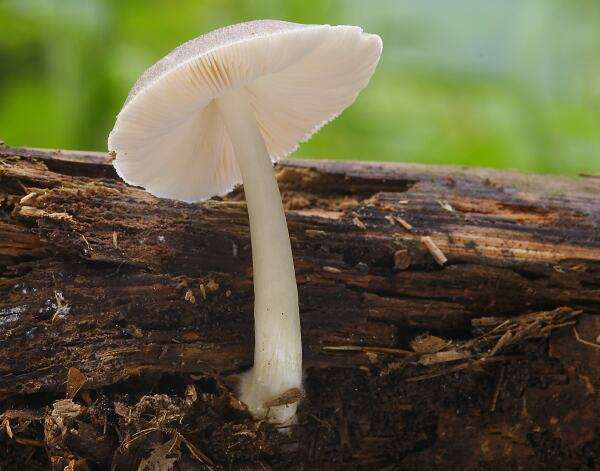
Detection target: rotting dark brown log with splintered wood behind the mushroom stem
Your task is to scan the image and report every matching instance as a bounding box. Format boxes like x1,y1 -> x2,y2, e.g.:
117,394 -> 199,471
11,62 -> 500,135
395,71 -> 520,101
0,147 -> 600,469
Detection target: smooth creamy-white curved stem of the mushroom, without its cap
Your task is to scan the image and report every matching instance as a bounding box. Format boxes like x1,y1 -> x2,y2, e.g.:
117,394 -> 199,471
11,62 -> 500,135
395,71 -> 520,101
216,88 -> 302,425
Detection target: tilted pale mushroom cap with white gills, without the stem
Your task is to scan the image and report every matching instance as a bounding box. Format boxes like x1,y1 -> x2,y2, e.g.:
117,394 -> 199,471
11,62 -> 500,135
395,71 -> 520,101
108,20 -> 382,202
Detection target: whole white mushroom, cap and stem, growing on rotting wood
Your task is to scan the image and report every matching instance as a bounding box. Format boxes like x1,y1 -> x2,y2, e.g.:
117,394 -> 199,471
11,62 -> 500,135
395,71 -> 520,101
108,20 -> 382,425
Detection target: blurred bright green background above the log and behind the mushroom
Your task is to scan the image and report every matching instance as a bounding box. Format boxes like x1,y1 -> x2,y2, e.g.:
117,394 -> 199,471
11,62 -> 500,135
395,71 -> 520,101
0,0 -> 600,174
